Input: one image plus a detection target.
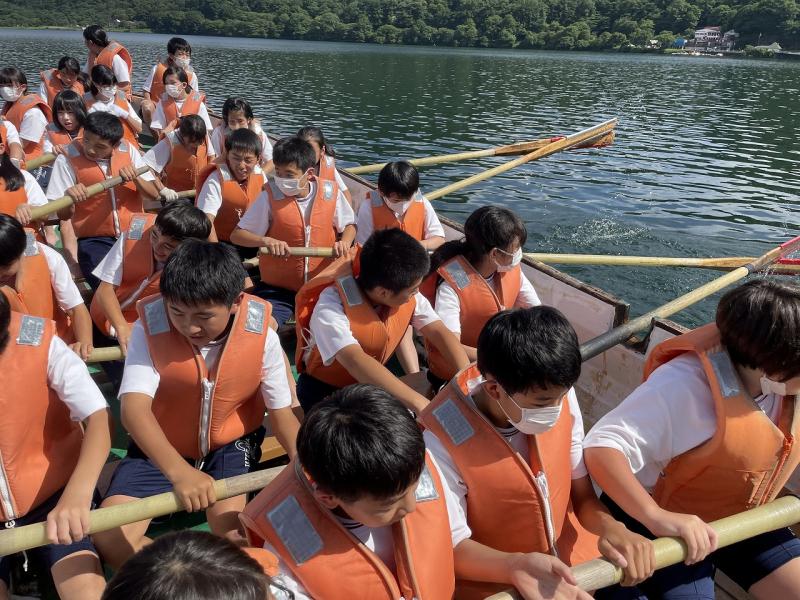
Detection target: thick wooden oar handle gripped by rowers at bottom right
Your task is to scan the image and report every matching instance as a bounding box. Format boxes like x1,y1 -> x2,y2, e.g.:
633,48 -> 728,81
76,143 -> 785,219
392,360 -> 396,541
486,496 -> 800,600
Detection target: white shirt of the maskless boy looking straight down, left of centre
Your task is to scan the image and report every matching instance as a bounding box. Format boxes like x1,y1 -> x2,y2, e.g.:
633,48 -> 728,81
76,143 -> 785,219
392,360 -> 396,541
119,321 -> 292,410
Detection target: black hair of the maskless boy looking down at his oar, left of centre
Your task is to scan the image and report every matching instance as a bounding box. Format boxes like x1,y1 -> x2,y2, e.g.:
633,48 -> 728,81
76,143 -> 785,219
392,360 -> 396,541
159,239 -> 247,307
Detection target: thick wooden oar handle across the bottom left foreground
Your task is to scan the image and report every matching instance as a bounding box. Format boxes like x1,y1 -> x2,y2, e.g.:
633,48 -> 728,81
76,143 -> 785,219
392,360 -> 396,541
0,467 -> 283,556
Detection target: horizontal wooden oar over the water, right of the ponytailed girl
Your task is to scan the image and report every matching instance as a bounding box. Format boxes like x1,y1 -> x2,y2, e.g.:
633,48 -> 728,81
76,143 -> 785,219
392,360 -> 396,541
524,252 -> 800,273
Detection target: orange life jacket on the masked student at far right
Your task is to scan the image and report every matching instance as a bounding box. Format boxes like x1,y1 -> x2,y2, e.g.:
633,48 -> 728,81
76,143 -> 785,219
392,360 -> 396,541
644,323 -> 800,522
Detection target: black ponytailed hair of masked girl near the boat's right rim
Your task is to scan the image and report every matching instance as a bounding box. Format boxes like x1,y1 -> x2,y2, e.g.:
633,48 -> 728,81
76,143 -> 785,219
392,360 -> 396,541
431,205 -> 528,272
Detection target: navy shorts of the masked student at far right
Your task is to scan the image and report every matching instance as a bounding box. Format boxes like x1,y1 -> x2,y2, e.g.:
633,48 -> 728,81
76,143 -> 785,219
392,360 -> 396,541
594,494 -> 800,600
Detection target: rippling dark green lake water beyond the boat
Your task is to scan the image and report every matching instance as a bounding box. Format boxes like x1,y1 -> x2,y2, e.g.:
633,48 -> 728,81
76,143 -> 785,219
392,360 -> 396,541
0,29 -> 800,325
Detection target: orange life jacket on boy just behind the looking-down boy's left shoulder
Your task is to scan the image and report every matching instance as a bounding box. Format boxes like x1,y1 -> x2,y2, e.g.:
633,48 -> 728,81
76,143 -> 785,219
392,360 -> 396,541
89,214 -> 161,335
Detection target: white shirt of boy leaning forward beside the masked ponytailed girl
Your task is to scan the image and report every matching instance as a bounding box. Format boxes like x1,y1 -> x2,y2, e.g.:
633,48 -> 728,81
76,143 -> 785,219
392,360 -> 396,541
306,286 -> 440,366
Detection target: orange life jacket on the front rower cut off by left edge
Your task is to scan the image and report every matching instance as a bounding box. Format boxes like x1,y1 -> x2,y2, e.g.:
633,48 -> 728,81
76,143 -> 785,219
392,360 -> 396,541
0,312 -> 83,521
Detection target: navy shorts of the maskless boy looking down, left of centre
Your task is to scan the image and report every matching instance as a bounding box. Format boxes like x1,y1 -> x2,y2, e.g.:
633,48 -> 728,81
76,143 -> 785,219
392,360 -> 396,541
104,427 -> 264,498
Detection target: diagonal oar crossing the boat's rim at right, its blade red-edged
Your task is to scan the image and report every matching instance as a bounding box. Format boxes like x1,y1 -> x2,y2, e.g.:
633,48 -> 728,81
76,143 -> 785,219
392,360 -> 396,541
581,236 -> 800,360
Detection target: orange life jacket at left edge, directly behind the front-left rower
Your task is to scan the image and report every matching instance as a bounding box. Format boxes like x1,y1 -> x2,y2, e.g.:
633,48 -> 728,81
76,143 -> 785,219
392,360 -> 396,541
0,230 -> 73,341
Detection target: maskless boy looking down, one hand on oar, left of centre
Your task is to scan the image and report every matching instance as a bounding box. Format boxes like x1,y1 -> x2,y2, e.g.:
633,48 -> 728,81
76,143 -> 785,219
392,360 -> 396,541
95,240 -> 299,568
